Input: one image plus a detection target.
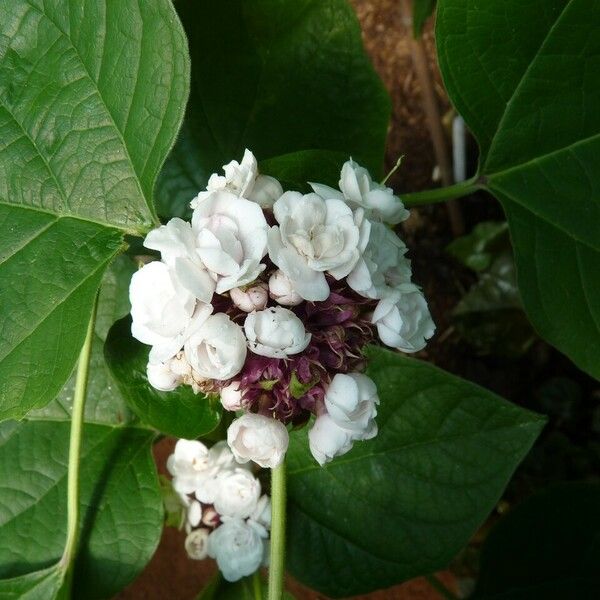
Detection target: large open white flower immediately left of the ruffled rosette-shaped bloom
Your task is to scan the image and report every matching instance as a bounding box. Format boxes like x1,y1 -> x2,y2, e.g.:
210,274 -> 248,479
192,191 -> 268,294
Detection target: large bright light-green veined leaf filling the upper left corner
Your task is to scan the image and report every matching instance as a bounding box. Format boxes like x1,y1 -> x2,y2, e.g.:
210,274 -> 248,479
0,0 -> 189,419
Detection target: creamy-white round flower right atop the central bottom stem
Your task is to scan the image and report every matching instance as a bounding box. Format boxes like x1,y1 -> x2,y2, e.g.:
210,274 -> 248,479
227,413 -> 289,469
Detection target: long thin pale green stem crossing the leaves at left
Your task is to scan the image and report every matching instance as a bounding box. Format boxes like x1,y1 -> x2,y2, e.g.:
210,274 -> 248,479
60,302 -> 96,589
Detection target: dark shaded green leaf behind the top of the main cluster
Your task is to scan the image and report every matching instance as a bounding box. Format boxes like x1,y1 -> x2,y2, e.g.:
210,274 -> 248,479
156,0 -> 390,216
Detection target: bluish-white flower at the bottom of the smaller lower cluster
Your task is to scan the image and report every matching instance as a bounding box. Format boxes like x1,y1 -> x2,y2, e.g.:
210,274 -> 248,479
208,519 -> 264,581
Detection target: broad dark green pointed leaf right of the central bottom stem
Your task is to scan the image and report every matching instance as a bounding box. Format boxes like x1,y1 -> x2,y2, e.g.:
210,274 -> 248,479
288,347 -> 544,597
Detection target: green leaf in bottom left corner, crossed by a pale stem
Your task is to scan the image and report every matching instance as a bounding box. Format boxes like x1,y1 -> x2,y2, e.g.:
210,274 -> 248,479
0,415 -> 163,599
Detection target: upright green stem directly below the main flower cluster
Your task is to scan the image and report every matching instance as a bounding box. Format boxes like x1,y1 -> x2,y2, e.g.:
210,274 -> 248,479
269,461 -> 286,600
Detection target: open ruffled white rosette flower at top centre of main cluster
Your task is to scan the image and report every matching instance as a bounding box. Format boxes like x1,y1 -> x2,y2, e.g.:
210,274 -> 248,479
269,192 -> 368,301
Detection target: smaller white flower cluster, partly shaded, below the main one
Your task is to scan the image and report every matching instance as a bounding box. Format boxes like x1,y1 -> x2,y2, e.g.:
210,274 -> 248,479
167,440 -> 271,581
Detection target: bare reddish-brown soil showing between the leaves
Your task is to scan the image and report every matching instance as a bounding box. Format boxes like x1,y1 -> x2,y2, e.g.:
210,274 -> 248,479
117,0 -> 461,600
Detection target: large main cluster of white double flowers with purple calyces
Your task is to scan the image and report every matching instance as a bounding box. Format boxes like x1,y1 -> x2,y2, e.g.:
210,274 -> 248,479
130,150 -> 434,467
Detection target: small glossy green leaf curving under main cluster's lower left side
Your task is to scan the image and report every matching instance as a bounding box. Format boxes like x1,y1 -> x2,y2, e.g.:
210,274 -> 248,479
105,317 -> 221,439
